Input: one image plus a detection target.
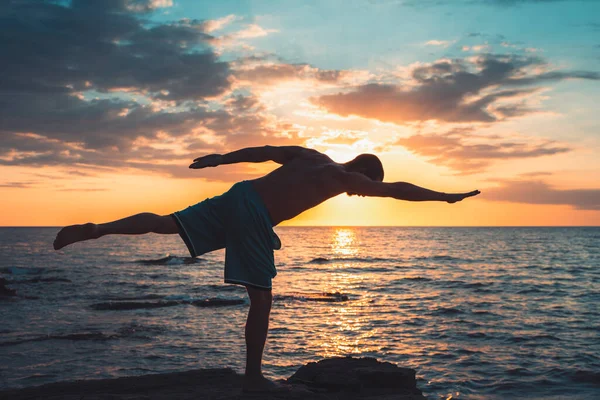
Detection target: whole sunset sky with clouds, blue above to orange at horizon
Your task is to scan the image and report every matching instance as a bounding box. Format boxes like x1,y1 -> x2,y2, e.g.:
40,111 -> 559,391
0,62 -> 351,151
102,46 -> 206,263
0,0 -> 600,226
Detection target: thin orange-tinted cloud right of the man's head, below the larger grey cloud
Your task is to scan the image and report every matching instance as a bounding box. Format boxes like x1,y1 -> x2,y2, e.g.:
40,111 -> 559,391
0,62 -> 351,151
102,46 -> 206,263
395,129 -> 571,174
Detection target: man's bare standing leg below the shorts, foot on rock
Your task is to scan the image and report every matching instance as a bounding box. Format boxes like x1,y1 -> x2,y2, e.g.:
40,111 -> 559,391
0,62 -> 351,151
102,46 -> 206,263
244,286 -> 277,391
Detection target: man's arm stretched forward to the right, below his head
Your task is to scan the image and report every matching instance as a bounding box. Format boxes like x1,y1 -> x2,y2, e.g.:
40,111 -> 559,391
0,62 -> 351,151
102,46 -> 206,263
342,173 -> 480,203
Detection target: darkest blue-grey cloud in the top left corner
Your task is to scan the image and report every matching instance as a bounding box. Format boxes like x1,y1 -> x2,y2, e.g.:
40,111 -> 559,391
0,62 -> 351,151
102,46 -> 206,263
0,0 -> 230,100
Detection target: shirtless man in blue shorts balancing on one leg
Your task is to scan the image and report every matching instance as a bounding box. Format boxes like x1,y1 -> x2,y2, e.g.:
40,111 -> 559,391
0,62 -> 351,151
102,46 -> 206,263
54,146 -> 479,391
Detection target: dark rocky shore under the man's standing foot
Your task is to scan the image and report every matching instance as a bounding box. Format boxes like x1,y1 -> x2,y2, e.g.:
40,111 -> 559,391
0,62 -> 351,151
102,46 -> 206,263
0,357 -> 425,400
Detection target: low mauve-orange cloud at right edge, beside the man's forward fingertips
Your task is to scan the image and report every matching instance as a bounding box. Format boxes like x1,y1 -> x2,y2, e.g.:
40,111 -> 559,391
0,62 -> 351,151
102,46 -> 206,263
482,181 -> 600,210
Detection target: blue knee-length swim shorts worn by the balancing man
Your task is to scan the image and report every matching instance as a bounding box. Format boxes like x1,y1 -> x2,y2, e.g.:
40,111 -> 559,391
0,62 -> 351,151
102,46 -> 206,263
173,181 -> 281,290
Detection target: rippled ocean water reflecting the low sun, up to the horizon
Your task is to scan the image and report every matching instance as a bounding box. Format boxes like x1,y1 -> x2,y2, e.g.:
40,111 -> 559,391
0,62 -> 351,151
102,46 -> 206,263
0,227 -> 600,399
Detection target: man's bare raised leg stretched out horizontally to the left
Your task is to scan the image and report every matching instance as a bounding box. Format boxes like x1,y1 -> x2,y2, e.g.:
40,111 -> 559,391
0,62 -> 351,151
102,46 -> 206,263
54,213 -> 179,250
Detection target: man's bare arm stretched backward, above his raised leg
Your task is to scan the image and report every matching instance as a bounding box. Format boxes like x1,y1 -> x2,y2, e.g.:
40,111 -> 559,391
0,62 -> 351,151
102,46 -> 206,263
190,146 -> 314,169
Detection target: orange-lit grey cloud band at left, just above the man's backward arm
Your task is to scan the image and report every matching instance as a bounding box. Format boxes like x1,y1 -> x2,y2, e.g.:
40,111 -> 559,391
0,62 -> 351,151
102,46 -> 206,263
0,95 -> 299,177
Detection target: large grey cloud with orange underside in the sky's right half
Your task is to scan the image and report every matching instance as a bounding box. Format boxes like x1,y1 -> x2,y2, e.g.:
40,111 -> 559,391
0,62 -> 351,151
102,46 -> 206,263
313,54 -> 600,124
